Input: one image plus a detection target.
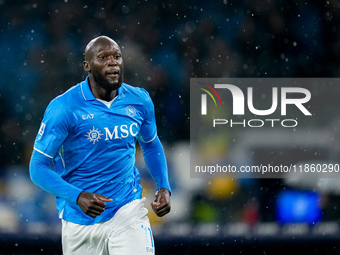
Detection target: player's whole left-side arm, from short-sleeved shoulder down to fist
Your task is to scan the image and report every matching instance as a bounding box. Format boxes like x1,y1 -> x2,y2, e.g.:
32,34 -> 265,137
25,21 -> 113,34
30,100 -> 111,217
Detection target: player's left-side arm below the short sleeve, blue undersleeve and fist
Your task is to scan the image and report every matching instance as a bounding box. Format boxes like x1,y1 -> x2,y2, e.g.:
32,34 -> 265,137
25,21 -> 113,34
30,150 -> 112,218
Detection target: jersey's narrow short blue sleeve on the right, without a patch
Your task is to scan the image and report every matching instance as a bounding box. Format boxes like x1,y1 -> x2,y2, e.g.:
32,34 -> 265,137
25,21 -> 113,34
138,89 -> 157,143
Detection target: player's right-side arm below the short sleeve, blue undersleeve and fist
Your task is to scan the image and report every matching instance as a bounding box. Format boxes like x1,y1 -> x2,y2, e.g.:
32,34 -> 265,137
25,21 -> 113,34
139,136 -> 171,217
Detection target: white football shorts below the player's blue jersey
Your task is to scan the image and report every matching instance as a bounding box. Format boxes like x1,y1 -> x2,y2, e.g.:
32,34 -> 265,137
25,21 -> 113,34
62,198 -> 155,255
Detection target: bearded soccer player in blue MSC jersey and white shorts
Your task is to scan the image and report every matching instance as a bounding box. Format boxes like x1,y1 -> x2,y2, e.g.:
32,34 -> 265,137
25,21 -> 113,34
30,36 -> 171,255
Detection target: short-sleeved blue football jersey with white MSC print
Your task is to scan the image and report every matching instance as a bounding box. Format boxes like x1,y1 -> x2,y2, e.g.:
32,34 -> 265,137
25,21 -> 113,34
34,78 -> 157,224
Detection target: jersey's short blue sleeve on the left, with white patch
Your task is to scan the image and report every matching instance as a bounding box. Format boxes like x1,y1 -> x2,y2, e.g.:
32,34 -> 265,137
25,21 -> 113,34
34,99 -> 70,158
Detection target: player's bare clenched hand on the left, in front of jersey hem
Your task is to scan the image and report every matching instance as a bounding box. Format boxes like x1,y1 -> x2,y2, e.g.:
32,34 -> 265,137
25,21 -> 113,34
77,191 -> 112,218
